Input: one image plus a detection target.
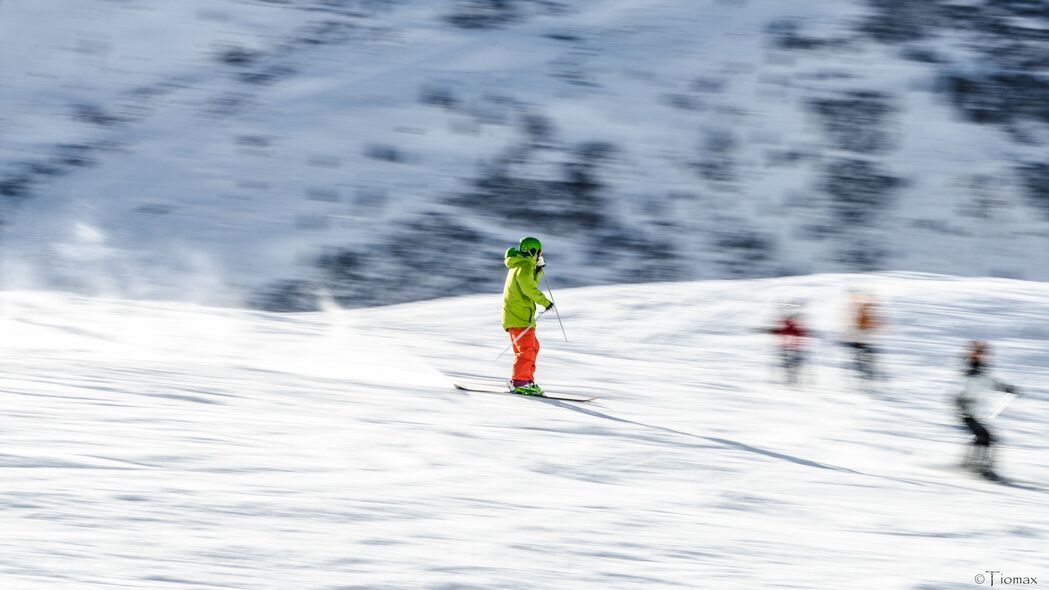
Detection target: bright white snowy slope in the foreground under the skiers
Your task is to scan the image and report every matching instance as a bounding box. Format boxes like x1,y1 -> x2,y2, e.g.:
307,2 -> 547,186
0,275 -> 1049,590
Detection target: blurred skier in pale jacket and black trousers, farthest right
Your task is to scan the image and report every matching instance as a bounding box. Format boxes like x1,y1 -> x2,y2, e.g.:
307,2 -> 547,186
955,340 -> 1019,479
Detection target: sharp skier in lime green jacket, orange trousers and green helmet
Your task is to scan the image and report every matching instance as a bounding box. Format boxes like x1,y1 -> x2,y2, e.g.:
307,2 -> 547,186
502,236 -> 554,396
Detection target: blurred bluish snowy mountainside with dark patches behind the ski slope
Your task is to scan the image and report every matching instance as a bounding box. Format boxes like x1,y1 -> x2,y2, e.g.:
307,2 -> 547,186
0,0 -> 1049,309
